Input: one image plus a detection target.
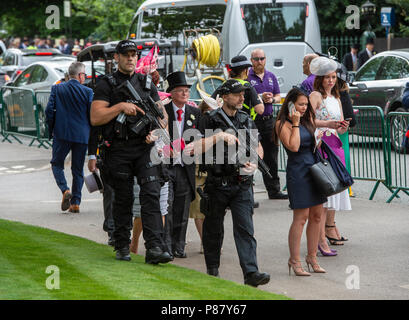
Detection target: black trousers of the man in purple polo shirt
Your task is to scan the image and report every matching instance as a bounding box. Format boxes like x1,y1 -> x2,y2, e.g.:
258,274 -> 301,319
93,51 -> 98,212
255,118 -> 280,194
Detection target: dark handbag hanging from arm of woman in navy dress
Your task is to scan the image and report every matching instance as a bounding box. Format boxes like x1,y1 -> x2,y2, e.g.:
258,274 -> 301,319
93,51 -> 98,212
310,143 -> 348,197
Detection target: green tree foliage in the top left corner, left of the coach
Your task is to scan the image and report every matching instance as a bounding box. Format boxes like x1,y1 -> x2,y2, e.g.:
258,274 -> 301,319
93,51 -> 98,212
0,0 -> 143,40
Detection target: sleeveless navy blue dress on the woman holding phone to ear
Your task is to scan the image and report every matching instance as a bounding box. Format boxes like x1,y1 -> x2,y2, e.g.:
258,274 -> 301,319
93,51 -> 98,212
284,124 -> 327,209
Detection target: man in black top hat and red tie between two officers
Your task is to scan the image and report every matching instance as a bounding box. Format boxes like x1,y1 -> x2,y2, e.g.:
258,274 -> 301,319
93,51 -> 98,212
165,71 -> 201,258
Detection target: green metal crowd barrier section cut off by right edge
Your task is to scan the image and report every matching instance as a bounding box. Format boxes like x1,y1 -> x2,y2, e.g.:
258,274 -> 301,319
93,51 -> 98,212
386,112 -> 409,203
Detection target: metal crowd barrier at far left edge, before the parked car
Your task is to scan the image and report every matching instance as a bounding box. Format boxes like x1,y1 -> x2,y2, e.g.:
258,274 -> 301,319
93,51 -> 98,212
0,86 -> 50,149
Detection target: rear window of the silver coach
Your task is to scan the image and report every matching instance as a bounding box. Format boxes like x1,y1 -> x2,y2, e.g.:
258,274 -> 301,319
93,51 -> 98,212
241,2 -> 307,43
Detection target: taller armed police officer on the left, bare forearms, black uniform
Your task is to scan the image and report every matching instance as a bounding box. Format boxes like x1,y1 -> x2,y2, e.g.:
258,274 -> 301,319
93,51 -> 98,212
91,40 -> 172,264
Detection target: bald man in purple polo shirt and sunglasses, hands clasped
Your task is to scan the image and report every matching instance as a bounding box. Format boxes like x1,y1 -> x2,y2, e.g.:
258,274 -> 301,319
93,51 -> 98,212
247,49 -> 288,199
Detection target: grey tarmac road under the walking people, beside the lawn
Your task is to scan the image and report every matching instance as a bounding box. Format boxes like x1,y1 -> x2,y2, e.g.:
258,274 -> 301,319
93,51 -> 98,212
0,142 -> 409,300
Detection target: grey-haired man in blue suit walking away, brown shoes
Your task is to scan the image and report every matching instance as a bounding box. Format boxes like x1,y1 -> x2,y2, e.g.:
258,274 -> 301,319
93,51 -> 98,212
45,62 -> 93,213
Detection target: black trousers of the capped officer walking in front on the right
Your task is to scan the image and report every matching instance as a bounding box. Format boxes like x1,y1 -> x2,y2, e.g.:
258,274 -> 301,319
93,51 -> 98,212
203,182 -> 258,277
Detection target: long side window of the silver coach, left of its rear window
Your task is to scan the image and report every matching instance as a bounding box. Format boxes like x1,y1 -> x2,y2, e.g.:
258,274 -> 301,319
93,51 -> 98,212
137,5 -> 226,54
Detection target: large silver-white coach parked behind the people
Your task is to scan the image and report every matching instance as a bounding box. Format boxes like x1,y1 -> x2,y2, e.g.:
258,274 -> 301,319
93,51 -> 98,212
128,0 -> 321,93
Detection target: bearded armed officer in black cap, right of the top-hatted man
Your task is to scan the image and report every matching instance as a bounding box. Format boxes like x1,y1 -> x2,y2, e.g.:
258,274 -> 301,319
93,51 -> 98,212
192,79 -> 270,287
